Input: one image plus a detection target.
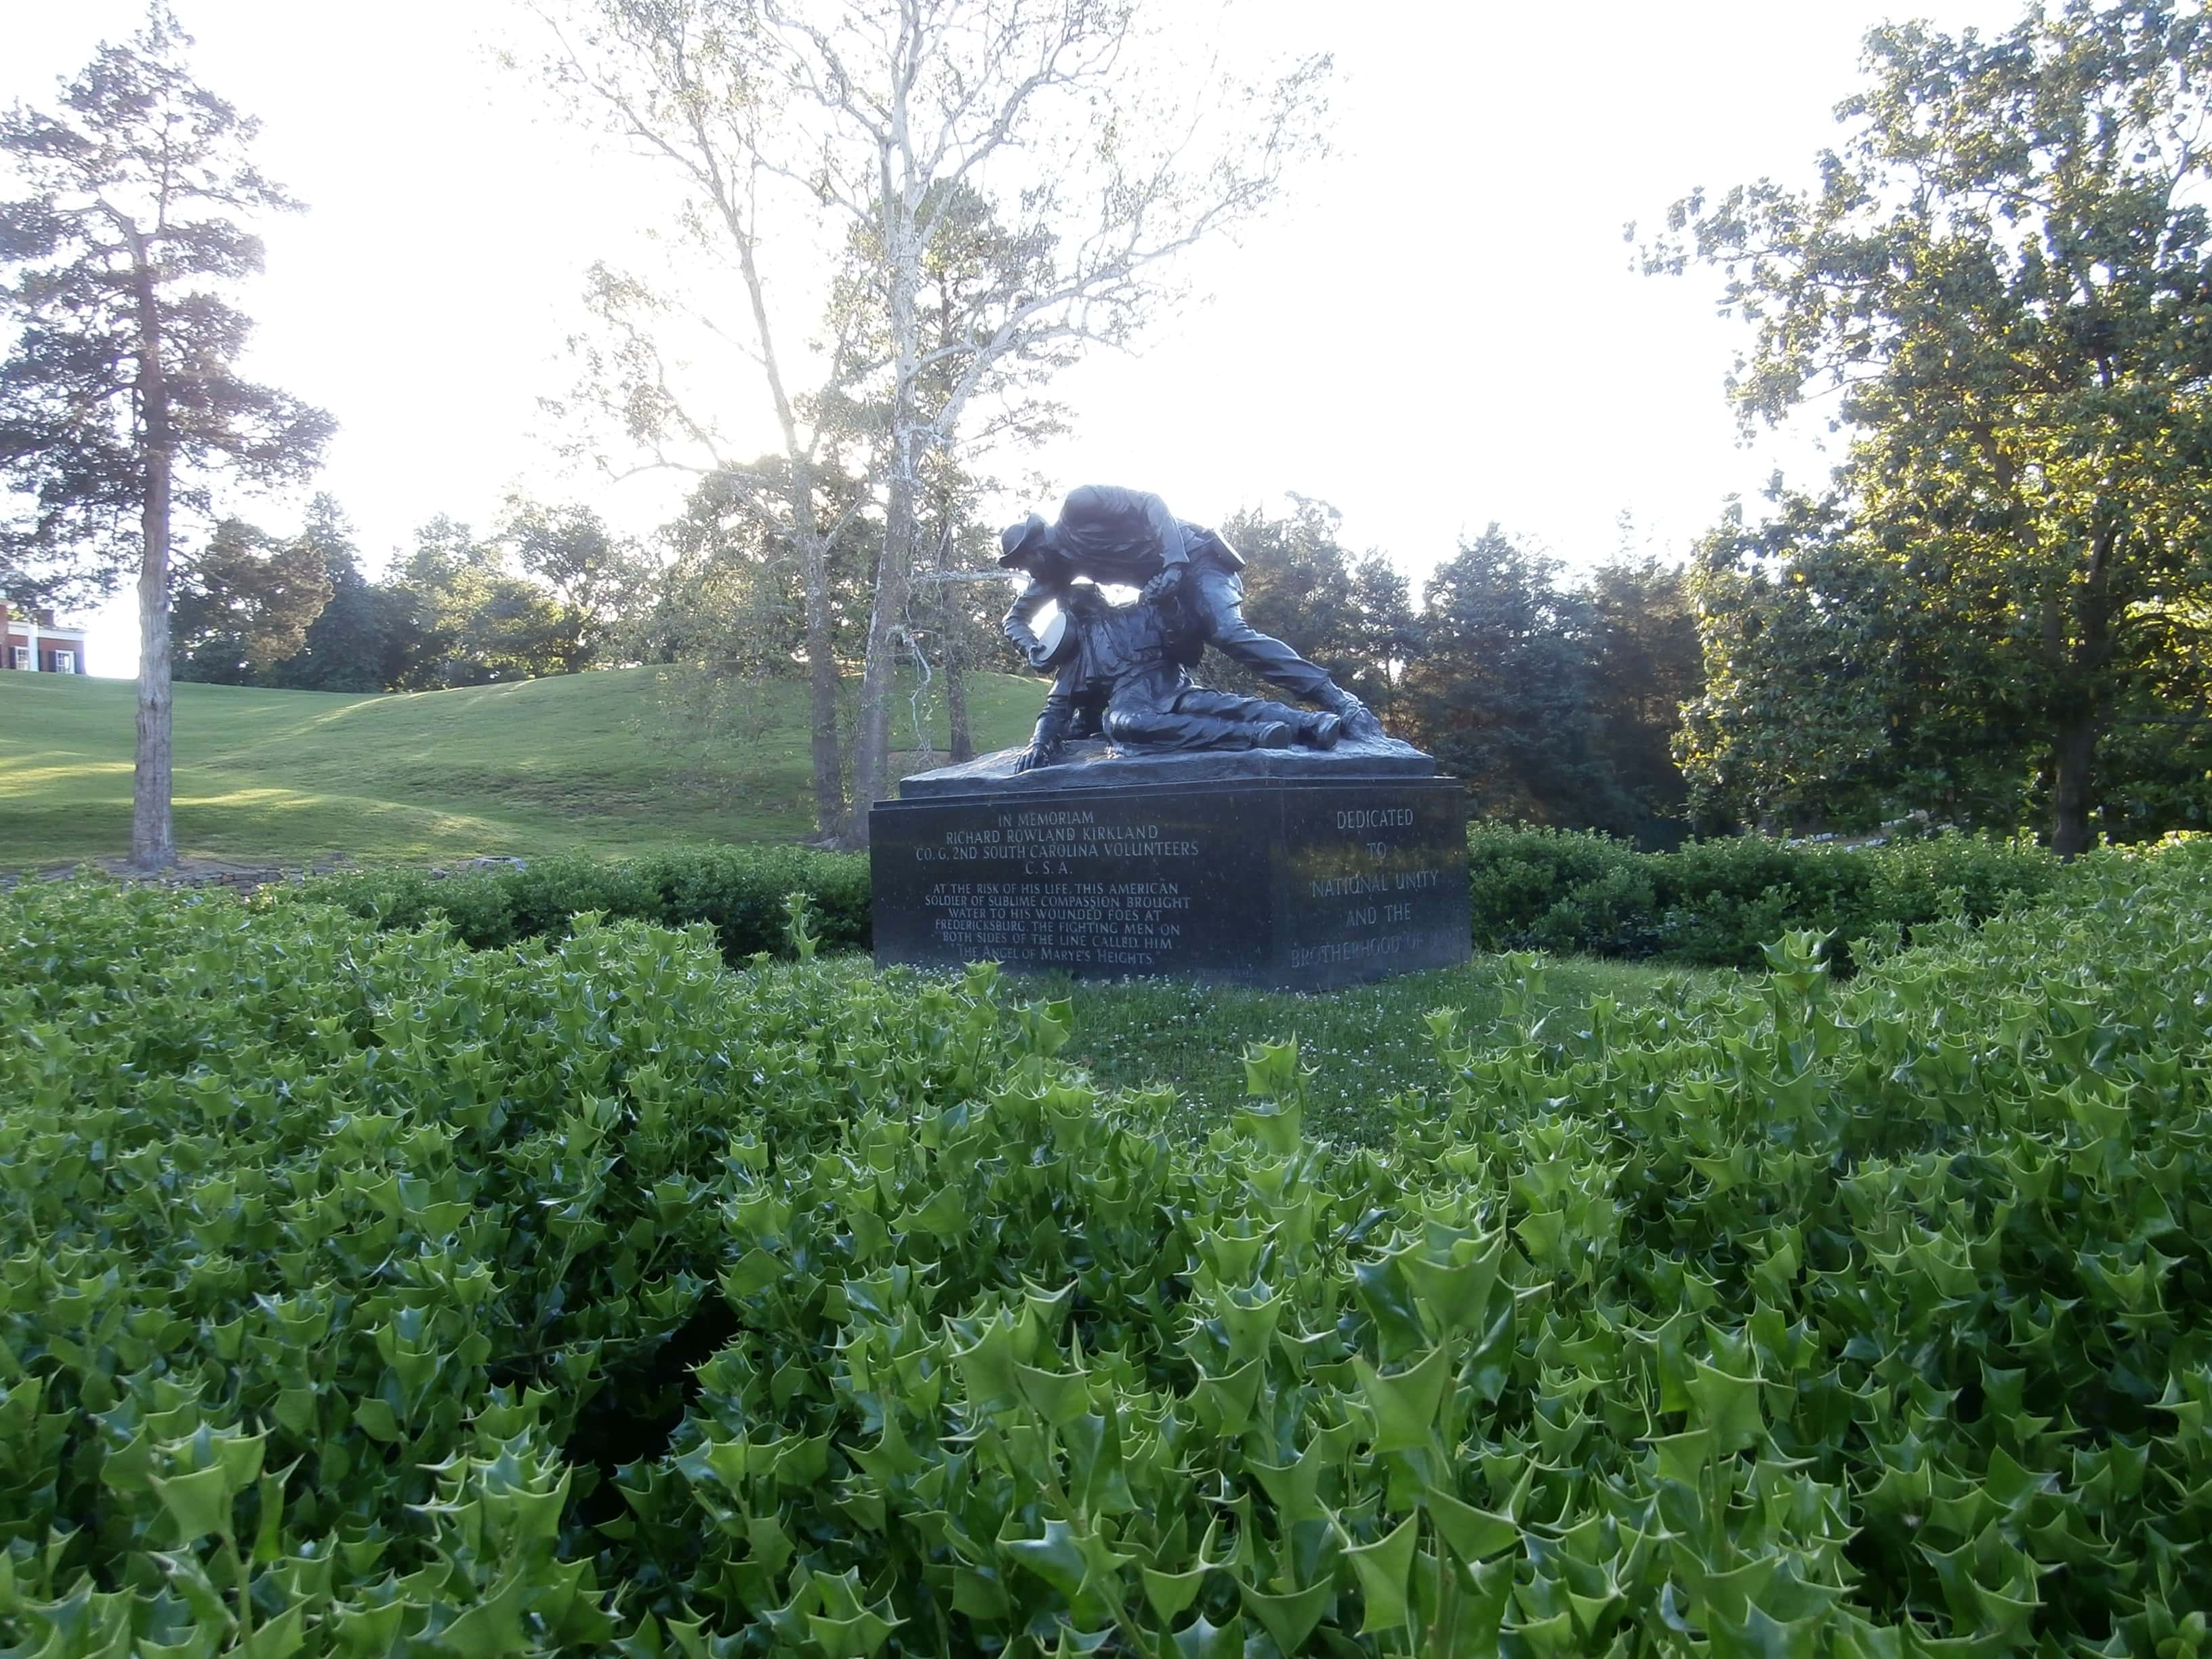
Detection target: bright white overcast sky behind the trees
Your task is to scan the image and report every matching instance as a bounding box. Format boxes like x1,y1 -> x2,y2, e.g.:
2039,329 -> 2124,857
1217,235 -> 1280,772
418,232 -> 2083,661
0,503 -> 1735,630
0,0 -> 2020,675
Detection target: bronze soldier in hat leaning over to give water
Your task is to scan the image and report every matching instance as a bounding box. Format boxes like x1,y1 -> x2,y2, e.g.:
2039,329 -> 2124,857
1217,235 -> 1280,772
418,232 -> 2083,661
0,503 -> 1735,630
1000,485 -> 1382,743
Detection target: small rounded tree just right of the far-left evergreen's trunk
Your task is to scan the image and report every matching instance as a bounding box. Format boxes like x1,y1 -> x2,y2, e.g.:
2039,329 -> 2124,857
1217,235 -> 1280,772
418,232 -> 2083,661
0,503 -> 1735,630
170,518 -> 334,686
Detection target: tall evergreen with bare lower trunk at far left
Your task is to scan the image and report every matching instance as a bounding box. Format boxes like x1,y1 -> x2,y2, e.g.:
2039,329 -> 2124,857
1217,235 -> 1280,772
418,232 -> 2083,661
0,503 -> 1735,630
0,5 -> 332,869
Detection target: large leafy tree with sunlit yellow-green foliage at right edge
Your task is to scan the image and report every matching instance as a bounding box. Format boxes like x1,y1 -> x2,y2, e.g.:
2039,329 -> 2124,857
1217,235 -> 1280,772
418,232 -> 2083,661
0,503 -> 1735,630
1645,0 -> 2212,854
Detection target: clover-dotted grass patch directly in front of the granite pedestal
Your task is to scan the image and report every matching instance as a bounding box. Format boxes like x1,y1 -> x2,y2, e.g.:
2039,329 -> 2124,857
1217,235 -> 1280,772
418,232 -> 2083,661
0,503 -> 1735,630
1022,956 -> 1739,1141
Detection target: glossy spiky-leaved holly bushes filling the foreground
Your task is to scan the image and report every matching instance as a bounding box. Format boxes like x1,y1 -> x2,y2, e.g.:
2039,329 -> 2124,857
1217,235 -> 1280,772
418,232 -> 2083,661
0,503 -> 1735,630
0,845 -> 2212,1659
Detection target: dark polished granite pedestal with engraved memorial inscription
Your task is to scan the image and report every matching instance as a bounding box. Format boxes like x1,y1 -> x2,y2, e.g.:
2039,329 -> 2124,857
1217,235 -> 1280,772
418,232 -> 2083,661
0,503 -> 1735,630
869,739 -> 1469,991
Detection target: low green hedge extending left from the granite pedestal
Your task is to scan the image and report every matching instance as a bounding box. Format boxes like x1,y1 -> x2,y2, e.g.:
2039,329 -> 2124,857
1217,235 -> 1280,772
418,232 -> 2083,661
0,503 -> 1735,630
298,847 -> 869,962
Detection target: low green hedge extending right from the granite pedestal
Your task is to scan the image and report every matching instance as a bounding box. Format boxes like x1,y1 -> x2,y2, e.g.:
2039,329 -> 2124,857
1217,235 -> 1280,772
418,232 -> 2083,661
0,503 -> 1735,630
1467,825 -> 2062,969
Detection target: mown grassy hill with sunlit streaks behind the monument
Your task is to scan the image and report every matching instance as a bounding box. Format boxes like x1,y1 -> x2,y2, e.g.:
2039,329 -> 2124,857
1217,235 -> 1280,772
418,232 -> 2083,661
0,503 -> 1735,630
0,668 -> 1042,869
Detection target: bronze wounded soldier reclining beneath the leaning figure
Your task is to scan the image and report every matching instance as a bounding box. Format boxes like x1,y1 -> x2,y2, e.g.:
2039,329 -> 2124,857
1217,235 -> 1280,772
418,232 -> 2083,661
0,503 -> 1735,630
1015,581 -> 1343,772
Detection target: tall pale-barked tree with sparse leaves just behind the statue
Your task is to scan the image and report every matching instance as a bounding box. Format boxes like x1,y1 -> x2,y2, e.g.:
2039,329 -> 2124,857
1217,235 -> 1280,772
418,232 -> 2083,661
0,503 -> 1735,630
535,0 -> 1327,838
